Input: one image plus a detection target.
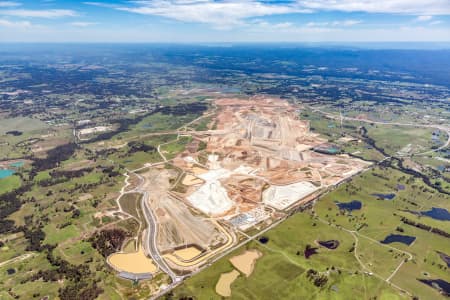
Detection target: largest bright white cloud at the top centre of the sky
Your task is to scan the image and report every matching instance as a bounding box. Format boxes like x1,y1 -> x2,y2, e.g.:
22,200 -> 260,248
89,0 -> 310,28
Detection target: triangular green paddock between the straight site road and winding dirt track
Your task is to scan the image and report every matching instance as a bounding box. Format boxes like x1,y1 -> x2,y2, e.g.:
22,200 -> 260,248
174,213 -> 403,299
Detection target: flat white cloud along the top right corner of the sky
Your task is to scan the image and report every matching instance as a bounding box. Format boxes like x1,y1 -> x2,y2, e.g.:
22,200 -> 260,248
297,0 -> 450,15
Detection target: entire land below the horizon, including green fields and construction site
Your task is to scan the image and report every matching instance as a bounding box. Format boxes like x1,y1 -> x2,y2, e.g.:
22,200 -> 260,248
0,44 -> 450,300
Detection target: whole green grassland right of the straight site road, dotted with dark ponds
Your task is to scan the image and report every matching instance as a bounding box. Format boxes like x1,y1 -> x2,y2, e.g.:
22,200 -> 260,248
175,168 -> 450,299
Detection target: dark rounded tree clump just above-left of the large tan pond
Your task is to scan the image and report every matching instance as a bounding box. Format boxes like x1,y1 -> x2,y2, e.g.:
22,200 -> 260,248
89,228 -> 129,257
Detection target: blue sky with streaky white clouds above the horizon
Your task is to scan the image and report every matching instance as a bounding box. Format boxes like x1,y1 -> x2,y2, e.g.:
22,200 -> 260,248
0,0 -> 450,43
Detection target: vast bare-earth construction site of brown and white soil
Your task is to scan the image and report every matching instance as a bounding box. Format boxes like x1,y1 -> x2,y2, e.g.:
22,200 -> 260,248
134,96 -> 369,274
